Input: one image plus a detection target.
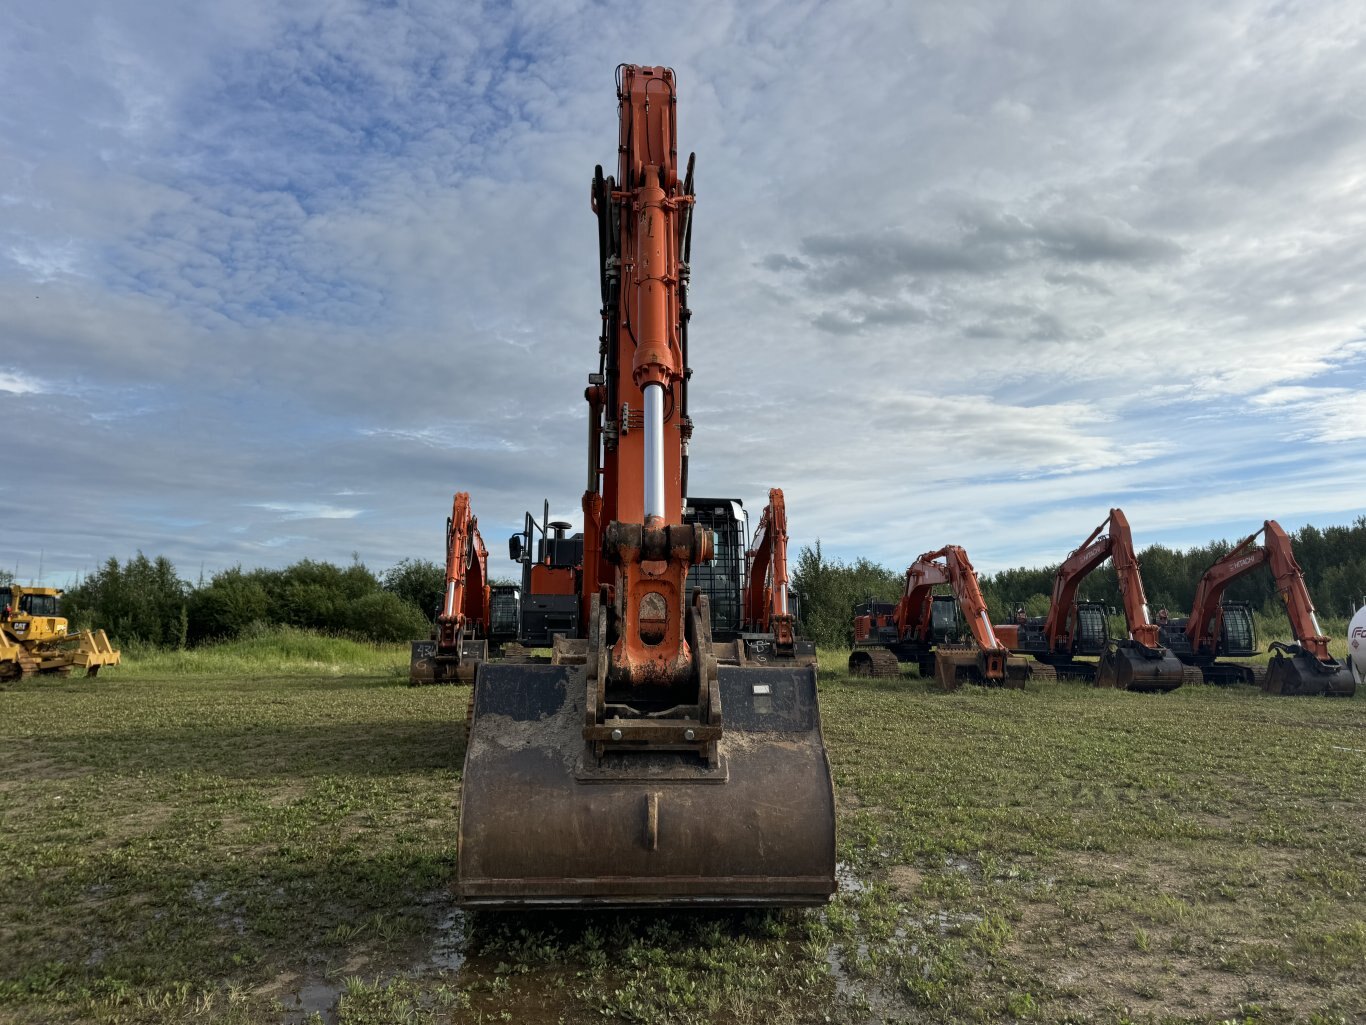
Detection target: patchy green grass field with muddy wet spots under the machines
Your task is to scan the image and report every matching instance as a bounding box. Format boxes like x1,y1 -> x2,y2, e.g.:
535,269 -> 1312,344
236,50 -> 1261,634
0,637 -> 1366,1025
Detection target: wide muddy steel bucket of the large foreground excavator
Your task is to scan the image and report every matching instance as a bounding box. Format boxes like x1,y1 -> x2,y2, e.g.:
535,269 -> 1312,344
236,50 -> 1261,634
455,663 -> 835,907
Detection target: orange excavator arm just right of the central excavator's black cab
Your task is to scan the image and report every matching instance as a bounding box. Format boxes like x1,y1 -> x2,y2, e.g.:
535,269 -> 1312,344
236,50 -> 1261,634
740,488 -> 816,666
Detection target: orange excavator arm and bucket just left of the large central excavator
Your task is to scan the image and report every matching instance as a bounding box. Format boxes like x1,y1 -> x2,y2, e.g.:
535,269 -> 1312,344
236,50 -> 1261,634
408,491 -> 492,685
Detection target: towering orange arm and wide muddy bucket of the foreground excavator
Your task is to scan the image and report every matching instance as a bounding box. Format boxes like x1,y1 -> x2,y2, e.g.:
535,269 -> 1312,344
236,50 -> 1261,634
456,66 -> 835,907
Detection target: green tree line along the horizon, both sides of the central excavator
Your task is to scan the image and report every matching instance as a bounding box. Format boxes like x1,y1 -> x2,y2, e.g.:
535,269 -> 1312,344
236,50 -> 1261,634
26,517 -> 1366,646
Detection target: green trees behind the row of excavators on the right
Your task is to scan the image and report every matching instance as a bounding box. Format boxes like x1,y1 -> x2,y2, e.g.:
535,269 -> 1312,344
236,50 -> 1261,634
792,517 -> 1366,645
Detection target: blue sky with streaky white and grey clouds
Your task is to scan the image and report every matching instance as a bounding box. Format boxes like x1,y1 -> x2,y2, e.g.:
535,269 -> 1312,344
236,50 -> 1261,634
0,0 -> 1366,584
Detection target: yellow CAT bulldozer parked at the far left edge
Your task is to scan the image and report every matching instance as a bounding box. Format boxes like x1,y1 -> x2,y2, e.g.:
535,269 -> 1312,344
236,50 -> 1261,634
0,584 -> 119,681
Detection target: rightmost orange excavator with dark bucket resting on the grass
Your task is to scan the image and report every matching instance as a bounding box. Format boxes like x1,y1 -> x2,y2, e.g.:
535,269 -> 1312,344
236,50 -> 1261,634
1162,519 -> 1356,697
